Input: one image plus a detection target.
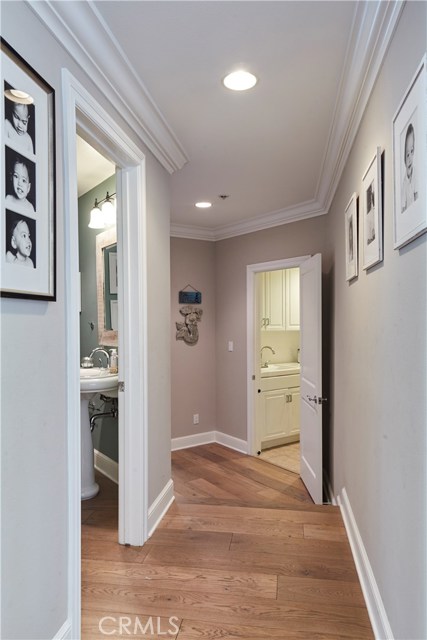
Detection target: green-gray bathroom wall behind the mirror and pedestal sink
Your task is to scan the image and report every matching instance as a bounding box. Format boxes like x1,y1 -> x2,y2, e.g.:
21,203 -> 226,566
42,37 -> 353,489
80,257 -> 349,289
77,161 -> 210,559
79,174 -> 119,462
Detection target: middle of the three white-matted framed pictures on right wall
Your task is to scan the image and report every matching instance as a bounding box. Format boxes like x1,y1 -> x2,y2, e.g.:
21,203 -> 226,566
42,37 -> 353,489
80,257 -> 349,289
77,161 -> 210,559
361,147 -> 383,269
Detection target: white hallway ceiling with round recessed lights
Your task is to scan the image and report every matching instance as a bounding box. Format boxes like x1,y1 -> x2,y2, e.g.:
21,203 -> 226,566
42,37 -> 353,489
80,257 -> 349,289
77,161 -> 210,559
65,0 -> 400,239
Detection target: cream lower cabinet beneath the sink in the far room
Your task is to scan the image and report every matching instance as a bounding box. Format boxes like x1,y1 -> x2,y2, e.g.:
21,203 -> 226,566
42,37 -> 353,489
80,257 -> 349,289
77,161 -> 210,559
259,375 -> 300,448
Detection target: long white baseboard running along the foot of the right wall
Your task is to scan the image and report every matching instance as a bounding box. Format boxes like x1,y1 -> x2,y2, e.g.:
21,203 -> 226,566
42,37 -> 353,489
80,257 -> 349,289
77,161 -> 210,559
337,488 -> 393,640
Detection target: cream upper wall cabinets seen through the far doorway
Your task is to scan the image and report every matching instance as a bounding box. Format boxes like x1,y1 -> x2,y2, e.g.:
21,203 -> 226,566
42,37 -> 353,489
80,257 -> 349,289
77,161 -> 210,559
261,267 -> 300,331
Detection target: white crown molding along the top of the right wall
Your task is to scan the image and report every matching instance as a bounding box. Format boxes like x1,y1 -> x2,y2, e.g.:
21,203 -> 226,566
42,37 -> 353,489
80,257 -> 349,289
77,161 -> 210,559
316,0 -> 405,210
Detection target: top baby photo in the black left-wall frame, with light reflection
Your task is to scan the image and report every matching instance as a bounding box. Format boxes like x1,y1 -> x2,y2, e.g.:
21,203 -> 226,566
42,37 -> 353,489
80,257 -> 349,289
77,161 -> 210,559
4,81 -> 36,156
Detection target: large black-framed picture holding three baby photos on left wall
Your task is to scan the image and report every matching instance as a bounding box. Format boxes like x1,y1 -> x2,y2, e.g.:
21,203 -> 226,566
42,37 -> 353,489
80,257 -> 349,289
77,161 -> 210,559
0,39 -> 56,300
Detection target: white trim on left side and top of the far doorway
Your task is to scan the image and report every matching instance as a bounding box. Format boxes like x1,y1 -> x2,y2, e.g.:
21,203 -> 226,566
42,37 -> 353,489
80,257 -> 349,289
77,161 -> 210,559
246,256 -> 310,455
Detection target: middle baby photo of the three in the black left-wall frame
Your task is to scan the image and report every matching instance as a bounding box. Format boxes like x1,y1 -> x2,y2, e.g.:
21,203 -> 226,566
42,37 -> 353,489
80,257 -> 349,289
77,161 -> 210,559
5,147 -> 36,215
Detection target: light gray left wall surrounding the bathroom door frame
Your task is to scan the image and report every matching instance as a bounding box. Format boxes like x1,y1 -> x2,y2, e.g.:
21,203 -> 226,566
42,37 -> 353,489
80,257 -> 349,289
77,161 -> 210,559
0,1 -> 170,640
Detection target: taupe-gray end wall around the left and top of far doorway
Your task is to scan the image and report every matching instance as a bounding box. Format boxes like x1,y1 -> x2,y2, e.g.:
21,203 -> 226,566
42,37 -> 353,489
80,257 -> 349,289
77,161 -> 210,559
215,216 -> 328,441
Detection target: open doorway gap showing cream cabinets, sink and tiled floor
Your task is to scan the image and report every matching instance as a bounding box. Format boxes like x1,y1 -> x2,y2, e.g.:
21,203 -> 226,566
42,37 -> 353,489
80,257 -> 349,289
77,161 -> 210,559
254,267 -> 300,475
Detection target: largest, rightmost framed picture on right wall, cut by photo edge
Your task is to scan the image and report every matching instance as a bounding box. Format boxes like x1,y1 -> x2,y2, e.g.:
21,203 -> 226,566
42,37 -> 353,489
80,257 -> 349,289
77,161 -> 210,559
393,56 -> 427,249
